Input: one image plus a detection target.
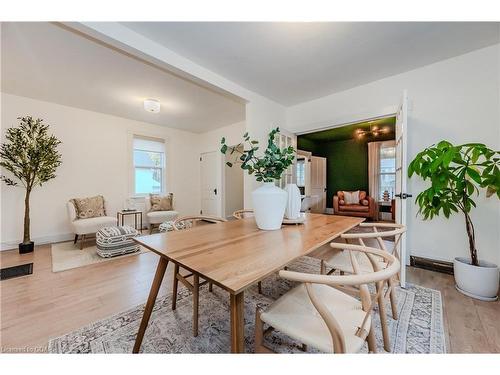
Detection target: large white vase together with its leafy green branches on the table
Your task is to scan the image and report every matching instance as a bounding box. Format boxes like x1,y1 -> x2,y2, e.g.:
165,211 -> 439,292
220,128 -> 295,230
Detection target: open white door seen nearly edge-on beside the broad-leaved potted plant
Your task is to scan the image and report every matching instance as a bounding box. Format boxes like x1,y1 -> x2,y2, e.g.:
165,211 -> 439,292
394,90 -> 411,288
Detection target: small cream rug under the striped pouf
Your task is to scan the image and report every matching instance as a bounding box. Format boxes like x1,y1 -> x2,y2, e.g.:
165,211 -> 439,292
51,241 -> 148,272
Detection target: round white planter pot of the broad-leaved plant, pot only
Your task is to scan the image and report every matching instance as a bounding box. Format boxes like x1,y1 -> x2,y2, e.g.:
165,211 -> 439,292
453,257 -> 499,301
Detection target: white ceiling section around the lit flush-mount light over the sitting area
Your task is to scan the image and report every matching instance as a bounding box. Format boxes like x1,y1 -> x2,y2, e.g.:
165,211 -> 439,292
1,23 -> 245,132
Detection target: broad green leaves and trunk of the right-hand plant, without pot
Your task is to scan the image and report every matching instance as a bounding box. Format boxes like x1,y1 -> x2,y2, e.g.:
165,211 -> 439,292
408,141 -> 500,266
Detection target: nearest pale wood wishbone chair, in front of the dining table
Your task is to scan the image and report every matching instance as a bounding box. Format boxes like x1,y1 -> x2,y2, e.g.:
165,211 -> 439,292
255,243 -> 400,353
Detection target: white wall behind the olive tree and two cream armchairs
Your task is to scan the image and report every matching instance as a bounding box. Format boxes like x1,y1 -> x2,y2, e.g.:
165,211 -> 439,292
1,94 -> 201,248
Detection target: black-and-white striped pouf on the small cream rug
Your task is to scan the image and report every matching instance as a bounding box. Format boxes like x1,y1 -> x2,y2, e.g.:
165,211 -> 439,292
96,225 -> 140,258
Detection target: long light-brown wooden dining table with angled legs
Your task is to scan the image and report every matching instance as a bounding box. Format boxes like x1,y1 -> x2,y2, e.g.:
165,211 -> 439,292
133,213 -> 364,353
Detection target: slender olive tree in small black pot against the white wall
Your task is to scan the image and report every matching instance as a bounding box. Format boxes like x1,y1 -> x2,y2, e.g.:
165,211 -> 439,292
0,116 -> 61,254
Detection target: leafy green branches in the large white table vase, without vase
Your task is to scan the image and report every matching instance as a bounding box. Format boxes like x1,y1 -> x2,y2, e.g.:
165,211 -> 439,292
220,128 -> 295,182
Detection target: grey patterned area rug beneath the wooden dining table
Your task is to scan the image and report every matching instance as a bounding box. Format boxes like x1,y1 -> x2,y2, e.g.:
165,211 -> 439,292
49,257 -> 446,353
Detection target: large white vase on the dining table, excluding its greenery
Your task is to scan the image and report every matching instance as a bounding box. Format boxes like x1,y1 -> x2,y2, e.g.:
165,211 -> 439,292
252,182 -> 287,230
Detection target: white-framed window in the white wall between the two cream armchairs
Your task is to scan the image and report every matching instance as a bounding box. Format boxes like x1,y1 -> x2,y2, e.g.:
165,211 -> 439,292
134,136 -> 165,195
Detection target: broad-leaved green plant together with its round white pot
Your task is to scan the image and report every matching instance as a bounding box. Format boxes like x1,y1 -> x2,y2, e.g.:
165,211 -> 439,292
408,141 -> 500,301
